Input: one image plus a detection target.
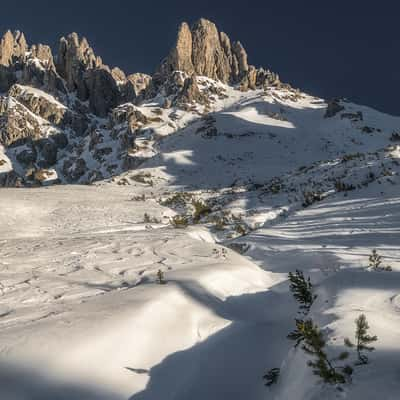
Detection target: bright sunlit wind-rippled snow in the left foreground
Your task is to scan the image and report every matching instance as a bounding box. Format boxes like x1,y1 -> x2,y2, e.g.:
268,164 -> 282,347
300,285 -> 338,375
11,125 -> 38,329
0,187 -> 284,398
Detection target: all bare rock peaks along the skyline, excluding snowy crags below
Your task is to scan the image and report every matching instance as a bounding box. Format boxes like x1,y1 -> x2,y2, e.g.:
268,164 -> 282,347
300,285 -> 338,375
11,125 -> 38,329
0,19 -> 279,117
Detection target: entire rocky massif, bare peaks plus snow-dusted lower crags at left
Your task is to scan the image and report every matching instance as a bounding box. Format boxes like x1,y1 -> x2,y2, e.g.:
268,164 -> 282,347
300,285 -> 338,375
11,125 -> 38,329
0,19 -> 281,186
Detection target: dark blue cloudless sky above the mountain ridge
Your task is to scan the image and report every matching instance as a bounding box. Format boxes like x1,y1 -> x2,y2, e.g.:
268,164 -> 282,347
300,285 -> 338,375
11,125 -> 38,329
0,0 -> 400,115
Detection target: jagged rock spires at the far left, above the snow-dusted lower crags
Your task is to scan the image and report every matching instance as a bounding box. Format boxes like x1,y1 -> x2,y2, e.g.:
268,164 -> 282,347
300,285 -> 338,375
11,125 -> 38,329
0,31 -> 151,117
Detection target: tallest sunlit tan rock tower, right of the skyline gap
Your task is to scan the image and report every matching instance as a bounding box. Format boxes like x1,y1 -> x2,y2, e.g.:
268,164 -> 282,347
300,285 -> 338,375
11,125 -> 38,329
153,19 -> 276,90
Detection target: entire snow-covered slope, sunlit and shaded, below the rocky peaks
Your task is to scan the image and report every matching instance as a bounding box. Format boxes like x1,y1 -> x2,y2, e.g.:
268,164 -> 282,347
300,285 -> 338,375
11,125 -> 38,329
0,78 -> 400,400
